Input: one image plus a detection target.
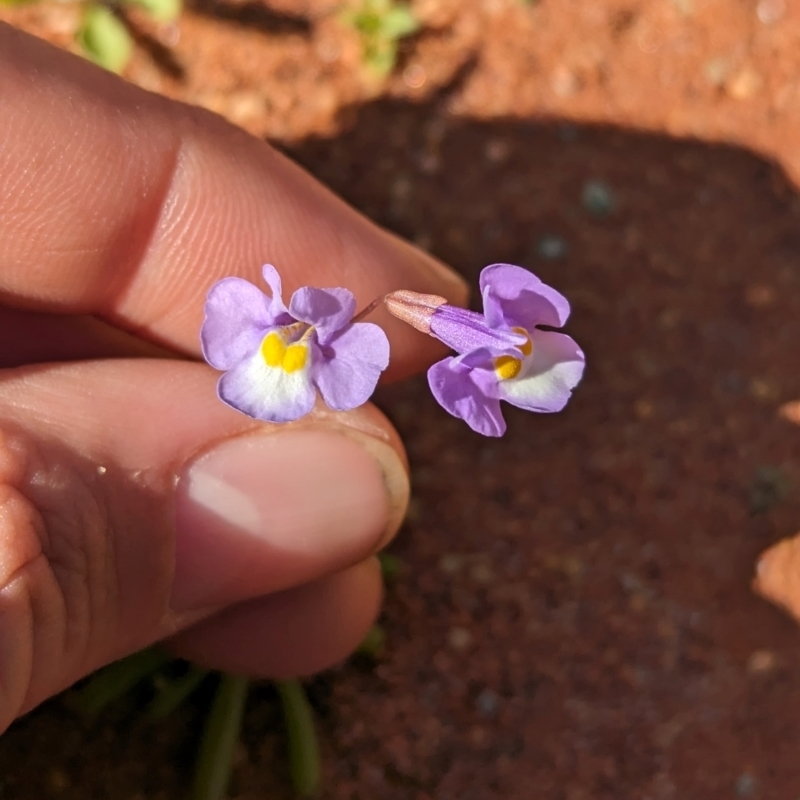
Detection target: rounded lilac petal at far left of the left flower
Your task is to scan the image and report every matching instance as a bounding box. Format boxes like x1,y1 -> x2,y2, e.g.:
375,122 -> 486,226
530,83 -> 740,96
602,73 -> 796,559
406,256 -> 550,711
200,278 -> 275,369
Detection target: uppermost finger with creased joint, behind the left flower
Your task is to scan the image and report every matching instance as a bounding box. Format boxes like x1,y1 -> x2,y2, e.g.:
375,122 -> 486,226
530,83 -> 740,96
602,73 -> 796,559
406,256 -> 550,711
0,24 -> 464,375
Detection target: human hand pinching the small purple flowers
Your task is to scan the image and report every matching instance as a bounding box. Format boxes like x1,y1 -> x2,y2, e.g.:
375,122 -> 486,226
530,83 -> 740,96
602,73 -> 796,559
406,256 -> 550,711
0,24 -> 464,730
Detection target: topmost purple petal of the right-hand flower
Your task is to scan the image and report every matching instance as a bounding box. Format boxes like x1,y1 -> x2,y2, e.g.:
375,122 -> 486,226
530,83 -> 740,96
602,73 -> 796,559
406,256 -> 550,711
480,264 -> 569,331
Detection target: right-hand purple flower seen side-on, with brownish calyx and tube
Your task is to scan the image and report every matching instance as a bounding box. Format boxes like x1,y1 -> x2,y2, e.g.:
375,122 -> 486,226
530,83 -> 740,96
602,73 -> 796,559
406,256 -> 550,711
385,264 -> 585,436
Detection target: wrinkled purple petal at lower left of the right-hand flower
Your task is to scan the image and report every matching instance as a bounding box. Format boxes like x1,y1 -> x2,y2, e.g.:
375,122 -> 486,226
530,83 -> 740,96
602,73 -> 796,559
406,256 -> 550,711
428,356 -> 506,436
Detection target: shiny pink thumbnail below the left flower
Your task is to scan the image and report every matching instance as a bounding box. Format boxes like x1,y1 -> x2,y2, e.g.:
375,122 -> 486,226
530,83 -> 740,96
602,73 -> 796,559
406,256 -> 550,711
171,429 -> 408,611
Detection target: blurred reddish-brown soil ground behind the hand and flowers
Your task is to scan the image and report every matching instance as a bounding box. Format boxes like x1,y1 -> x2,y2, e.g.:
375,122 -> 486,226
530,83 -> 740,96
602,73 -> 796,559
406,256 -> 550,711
0,0 -> 800,800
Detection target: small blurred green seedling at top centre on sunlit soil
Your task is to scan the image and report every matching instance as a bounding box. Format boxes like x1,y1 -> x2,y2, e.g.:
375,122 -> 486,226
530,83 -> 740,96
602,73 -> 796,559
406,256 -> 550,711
342,0 -> 420,78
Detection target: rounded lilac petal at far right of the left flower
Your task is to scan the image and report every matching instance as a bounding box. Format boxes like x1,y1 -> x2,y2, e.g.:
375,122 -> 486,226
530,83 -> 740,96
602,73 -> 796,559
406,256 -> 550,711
313,322 -> 389,411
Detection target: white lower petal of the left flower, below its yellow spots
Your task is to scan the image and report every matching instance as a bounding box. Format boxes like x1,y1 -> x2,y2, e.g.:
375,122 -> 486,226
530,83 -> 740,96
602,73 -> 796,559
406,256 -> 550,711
217,347 -> 317,422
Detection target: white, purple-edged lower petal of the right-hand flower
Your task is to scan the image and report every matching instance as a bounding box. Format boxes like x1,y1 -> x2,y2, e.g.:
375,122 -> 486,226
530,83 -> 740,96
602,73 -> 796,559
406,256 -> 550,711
498,330 -> 585,412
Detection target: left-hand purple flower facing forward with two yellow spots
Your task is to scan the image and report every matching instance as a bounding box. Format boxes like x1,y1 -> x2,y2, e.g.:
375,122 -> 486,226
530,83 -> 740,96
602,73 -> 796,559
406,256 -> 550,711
200,264 -> 389,422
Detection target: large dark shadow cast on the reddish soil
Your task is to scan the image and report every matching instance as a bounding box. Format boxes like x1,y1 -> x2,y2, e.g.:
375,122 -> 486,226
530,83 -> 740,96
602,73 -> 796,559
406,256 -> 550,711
0,81 -> 800,800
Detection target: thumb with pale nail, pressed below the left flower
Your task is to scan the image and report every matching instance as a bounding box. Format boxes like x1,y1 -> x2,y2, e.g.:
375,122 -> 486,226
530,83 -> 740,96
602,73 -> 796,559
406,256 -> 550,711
0,360 -> 408,730
